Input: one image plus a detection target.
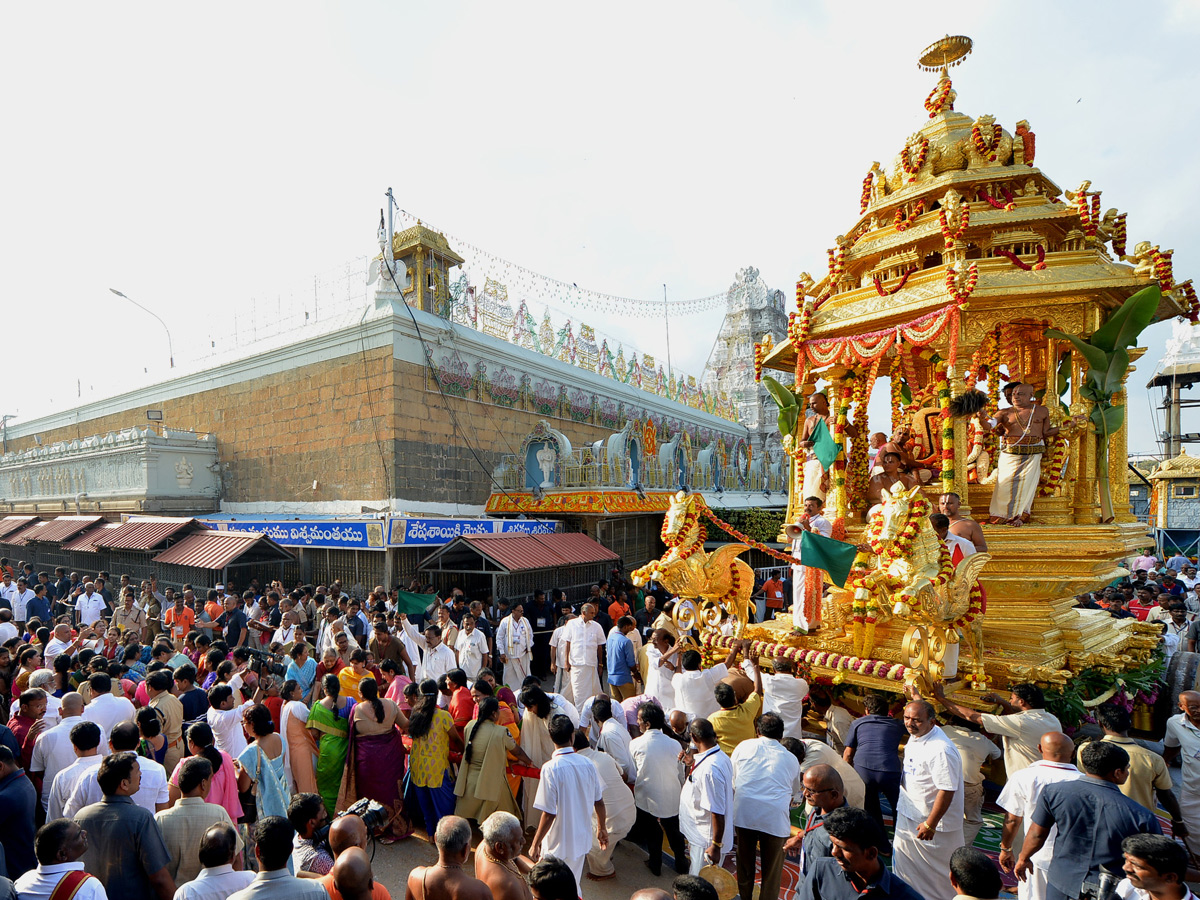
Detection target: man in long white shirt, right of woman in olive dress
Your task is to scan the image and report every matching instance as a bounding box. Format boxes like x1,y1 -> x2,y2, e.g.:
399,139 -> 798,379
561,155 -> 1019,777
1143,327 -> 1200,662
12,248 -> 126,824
529,715 -> 608,886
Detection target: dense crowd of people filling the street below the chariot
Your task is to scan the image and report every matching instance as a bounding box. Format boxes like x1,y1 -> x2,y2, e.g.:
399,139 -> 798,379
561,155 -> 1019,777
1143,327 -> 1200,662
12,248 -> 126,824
0,542 -> 1200,900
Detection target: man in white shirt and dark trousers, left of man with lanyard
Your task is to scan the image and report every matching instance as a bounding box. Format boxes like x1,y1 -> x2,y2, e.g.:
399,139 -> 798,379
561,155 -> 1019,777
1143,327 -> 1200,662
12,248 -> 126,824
629,703 -> 688,877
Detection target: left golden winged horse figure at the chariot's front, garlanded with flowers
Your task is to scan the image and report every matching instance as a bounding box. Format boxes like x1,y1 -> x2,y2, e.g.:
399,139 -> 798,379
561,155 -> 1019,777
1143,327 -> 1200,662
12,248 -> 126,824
630,491 -> 754,636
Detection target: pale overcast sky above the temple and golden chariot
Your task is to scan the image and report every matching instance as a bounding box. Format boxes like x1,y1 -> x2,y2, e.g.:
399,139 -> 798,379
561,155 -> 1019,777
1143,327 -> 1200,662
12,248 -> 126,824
0,0 -> 1200,451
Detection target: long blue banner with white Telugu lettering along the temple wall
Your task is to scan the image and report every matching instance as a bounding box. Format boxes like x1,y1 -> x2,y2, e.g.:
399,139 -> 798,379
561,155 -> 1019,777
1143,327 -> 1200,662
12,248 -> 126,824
205,516 -> 558,550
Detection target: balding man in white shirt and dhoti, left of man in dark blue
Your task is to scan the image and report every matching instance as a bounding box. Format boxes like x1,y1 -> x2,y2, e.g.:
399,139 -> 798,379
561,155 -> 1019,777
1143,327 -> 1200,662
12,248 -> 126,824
996,731 -> 1084,900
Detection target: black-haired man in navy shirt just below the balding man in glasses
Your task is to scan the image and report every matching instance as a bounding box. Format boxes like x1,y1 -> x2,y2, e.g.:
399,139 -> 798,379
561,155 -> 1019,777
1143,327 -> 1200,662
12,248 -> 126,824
799,806 -> 923,900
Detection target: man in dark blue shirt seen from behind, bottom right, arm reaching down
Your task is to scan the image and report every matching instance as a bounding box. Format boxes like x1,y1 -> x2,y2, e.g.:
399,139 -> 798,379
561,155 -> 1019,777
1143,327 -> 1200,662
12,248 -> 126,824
1014,740 -> 1163,900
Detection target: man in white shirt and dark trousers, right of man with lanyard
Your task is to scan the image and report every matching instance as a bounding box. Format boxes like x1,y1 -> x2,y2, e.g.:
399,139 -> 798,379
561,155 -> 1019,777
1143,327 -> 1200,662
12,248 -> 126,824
730,713 -> 804,900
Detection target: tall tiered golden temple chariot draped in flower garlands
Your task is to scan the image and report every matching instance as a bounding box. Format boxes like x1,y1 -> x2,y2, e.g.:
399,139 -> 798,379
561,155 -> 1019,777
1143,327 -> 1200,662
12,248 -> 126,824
646,36 -> 1200,702
